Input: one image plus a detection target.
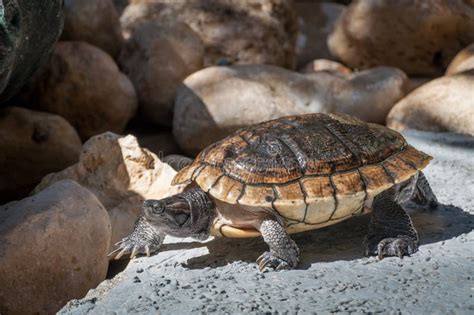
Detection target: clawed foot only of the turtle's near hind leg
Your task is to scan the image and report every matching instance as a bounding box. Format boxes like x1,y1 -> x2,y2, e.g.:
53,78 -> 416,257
366,235 -> 418,260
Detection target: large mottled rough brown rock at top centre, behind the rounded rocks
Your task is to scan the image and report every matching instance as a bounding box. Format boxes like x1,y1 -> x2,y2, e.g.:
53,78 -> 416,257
120,0 -> 297,68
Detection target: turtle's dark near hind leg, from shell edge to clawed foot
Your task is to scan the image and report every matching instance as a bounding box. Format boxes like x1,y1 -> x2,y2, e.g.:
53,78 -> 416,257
365,185 -> 418,259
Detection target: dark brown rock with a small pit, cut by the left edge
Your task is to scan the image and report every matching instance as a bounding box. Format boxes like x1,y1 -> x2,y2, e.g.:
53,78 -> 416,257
0,107 -> 81,204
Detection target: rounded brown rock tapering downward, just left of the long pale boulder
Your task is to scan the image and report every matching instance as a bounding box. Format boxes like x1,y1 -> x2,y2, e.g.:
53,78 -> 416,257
119,22 -> 204,125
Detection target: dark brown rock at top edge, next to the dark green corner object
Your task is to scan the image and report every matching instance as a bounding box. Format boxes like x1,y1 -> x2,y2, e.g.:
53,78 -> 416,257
61,0 -> 122,57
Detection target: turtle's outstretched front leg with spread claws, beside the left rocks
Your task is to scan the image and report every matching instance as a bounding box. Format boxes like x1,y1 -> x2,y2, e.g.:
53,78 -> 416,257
109,215 -> 165,259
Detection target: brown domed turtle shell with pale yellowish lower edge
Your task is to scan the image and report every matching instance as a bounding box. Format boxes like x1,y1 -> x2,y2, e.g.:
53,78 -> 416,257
173,113 -> 431,232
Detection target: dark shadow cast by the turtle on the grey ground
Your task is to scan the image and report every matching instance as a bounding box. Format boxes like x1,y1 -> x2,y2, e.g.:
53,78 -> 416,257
179,204 -> 474,269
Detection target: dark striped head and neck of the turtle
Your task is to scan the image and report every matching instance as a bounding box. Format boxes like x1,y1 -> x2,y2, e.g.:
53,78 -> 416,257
143,188 -> 215,240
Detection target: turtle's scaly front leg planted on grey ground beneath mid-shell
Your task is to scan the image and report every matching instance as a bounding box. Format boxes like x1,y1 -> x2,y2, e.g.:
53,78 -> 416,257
257,220 -> 300,271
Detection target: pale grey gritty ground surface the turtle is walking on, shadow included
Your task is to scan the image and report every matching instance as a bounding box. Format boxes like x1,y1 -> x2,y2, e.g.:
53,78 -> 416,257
61,132 -> 474,314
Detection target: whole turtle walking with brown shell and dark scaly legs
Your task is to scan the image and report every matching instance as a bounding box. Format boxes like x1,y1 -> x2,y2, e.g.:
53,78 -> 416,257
111,113 -> 437,271
